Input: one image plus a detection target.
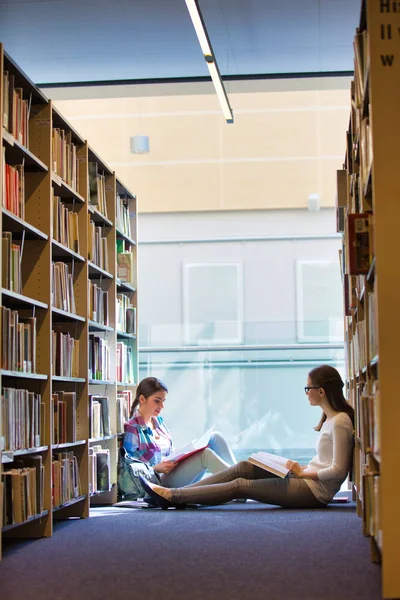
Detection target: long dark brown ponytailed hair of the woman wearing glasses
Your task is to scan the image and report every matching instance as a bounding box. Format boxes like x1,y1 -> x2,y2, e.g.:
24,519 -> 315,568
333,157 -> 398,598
308,365 -> 354,431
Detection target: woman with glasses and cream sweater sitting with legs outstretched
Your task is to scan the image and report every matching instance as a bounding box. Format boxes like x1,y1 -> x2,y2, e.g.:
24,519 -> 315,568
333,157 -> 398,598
139,365 -> 354,508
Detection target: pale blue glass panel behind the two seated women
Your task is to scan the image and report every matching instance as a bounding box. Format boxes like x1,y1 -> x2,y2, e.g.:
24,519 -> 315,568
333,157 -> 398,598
140,322 -> 344,462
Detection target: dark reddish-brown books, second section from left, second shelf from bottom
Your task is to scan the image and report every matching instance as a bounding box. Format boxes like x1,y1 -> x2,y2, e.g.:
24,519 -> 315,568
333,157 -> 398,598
51,391 -> 76,445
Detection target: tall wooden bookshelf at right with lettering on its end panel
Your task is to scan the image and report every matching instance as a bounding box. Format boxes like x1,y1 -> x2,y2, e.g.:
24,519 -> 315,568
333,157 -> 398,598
337,0 -> 400,598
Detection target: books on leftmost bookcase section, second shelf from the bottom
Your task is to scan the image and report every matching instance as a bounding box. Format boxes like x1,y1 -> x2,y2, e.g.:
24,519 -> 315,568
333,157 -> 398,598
0,387 -> 45,452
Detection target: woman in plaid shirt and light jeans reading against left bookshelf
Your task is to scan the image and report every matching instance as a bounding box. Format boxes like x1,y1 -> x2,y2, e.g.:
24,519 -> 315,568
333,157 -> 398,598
118,377 -> 236,500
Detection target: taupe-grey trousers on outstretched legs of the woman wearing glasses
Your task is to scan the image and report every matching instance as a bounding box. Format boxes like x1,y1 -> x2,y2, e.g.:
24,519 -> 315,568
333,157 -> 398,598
171,461 -> 325,508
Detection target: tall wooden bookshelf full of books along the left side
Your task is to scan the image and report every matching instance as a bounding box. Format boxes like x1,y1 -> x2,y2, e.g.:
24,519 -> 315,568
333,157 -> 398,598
0,45 -> 138,552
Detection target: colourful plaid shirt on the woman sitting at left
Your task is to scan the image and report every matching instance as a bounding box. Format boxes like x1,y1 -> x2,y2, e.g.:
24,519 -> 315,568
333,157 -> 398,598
124,411 -> 172,467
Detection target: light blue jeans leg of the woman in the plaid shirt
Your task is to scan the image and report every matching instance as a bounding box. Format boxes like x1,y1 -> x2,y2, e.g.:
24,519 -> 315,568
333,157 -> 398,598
161,448 -> 229,488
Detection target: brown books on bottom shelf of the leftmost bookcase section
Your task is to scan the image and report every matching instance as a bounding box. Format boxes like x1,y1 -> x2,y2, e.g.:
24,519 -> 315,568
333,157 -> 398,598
2,455 -> 44,526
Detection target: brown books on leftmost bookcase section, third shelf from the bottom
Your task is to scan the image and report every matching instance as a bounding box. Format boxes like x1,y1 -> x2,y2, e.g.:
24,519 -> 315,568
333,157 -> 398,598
0,306 -> 36,373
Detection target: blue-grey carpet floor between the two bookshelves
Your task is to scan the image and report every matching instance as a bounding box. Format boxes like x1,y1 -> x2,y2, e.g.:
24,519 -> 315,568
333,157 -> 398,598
0,503 -> 381,600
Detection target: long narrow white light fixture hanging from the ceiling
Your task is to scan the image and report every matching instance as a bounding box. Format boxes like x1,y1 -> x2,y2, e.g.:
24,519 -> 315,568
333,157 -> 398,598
185,0 -> 233,123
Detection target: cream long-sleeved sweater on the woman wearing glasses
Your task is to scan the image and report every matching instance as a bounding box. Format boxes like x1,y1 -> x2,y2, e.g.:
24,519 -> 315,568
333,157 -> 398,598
304,412 -> 354,504
